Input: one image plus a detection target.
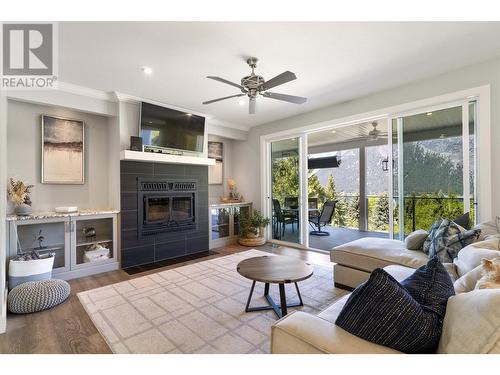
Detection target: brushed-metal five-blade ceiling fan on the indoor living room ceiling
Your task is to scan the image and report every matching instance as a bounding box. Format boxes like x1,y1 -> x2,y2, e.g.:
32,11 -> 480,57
203,57 -> 307,114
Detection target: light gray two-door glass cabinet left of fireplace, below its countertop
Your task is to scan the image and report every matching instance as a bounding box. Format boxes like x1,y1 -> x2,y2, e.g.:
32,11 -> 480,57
8,213 -> 119,280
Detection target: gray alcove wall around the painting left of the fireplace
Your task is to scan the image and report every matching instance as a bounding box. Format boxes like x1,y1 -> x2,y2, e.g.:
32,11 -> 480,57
7,100 -> 112,211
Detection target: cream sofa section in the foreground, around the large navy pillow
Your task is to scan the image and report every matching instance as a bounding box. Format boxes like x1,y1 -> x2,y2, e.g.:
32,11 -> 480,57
271,265 -> 500,354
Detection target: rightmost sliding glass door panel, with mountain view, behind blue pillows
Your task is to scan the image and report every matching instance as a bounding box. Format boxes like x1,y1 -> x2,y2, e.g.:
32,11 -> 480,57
392,102 -> 477,239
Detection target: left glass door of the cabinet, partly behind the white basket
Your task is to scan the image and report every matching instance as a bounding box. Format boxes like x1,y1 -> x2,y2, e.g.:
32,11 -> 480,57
11,221 -> 69,273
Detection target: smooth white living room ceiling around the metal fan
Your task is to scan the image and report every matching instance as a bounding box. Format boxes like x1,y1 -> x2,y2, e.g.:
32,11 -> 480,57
59,22 -> 500,131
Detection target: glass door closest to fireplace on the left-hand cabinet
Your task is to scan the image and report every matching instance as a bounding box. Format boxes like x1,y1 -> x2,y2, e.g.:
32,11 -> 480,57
72,217 -> 114,266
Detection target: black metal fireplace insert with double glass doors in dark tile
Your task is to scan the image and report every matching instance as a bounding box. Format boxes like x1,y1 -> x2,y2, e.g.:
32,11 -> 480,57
137,178 -> 197,238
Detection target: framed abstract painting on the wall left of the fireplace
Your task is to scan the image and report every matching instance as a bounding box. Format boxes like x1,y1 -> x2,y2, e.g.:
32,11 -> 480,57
42,115 -> 85,184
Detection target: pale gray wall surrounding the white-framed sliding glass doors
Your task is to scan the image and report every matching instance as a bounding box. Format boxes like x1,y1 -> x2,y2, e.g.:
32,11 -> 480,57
233,60 -> 500,215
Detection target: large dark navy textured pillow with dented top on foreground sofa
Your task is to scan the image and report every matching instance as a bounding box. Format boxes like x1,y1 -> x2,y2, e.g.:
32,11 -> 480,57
335,260 -> 454,353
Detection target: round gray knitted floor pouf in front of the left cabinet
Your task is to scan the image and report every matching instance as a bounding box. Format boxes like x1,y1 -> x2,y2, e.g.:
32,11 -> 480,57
7,279 -> 71,314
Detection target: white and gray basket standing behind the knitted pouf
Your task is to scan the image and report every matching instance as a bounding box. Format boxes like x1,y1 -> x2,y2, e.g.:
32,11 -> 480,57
9,256 -> 54,290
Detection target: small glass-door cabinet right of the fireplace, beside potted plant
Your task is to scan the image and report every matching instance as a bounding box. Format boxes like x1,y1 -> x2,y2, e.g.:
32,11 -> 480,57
210,202 -> 252,249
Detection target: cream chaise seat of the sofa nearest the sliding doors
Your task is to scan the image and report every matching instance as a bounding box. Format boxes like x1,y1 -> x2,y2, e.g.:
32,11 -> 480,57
330,238 -> 428,272
